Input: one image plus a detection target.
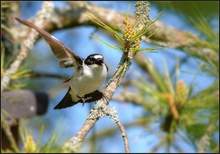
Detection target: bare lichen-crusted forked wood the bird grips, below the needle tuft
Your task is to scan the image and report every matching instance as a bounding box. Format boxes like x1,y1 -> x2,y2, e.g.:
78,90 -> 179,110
66,53 -> 132,153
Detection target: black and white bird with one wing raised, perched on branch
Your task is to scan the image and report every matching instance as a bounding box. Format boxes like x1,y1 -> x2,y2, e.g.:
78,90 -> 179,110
15,17 -> 108,109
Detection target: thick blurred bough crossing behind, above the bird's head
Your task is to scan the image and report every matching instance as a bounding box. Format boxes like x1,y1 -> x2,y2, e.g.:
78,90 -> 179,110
13,1 -> 219,62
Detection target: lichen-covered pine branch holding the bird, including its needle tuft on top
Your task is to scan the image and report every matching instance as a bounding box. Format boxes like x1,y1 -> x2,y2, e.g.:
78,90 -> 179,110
66,2 -> 155,153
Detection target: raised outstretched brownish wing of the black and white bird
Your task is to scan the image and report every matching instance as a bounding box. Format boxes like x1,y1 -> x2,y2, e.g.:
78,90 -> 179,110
15,18 -> 83,69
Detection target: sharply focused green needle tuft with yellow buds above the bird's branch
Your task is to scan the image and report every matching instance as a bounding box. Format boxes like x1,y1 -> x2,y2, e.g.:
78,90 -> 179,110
87,9 -> 163,52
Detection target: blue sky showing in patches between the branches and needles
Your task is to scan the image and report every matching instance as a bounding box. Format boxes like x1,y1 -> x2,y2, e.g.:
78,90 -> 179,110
15,1 -> 218,152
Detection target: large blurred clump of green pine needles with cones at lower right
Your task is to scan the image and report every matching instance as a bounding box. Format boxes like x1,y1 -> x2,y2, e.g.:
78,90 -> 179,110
134,53 -> 219,150
